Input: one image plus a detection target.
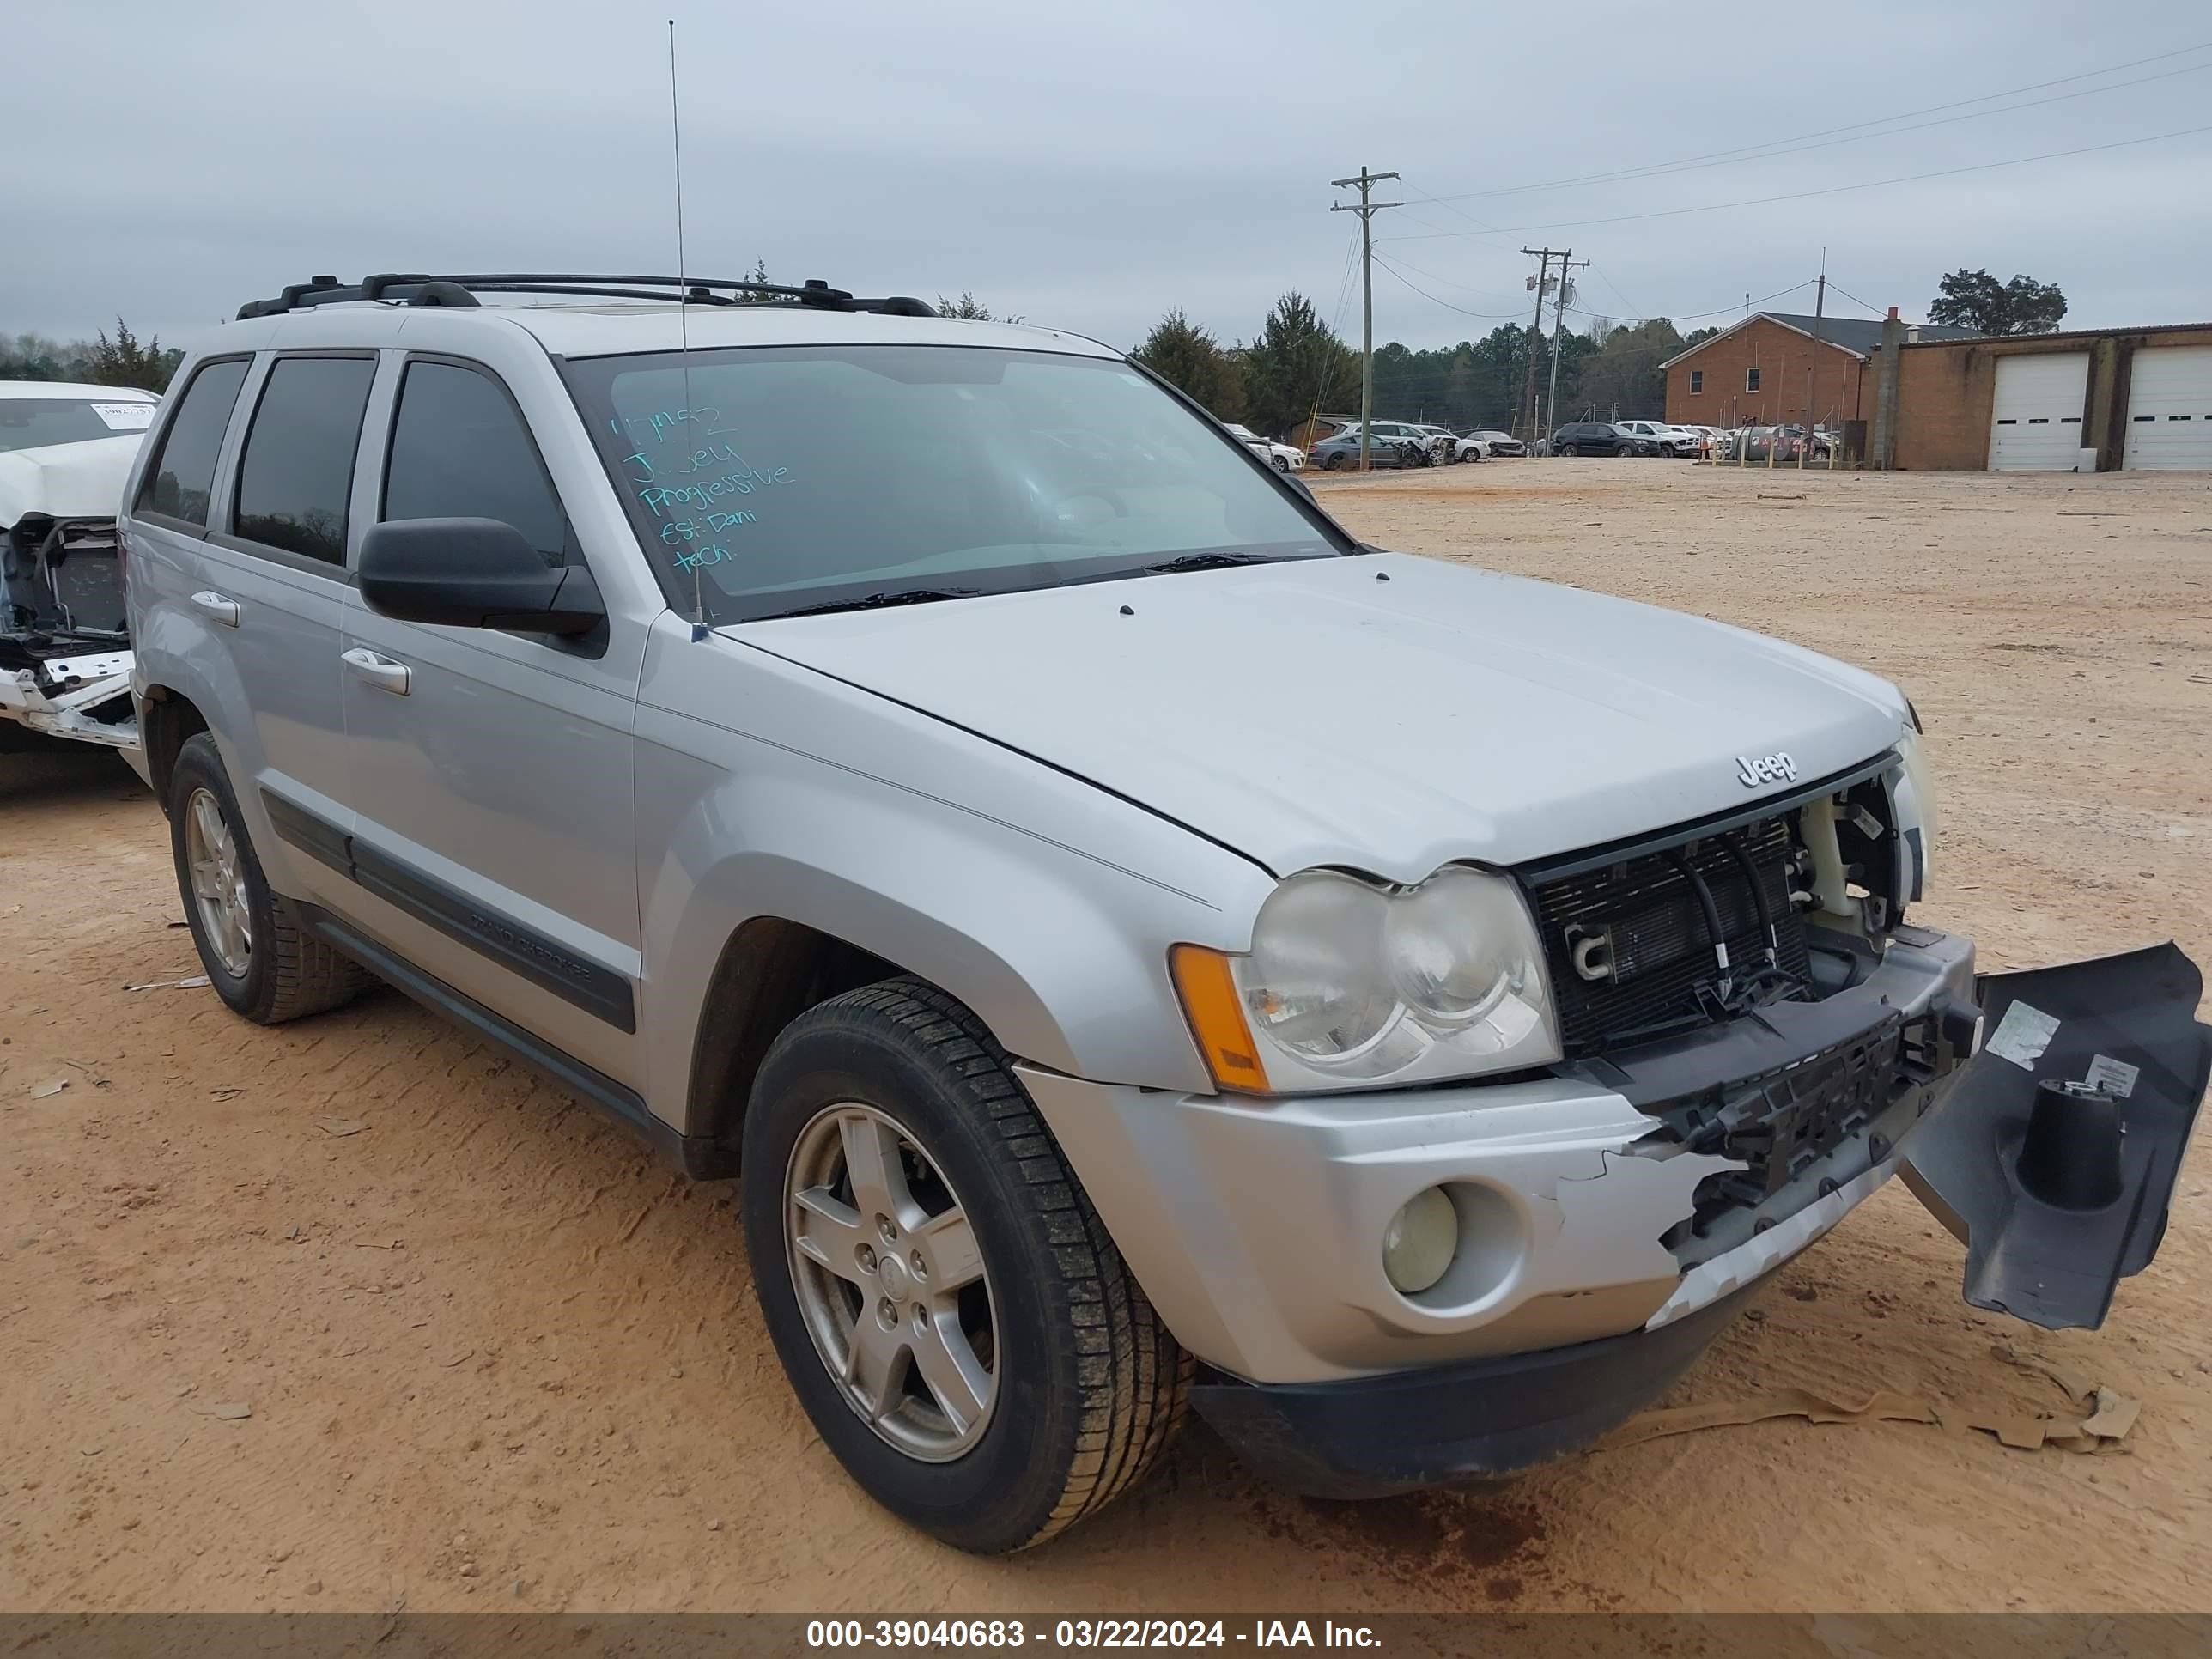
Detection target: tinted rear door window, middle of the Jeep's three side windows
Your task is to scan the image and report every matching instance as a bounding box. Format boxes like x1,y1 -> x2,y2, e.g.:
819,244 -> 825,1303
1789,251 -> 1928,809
232,356 -> 376,564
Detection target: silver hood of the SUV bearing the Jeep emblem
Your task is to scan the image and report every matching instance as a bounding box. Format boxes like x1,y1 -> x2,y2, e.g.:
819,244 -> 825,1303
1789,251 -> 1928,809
726,553 -> 1905,880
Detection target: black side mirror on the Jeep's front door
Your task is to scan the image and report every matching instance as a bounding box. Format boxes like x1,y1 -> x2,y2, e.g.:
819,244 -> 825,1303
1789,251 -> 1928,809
356,518 -> 606,635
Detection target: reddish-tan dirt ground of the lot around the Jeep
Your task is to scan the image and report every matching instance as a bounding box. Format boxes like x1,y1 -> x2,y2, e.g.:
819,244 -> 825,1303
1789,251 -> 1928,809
0,460 -> 2212,1614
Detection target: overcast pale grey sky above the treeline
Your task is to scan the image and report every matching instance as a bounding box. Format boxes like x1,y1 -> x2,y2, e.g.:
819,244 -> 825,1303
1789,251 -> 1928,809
0,0 -> 2212,345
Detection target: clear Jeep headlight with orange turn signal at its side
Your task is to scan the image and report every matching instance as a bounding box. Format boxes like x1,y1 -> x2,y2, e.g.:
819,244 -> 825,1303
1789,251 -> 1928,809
1175,865 -> 1559,1093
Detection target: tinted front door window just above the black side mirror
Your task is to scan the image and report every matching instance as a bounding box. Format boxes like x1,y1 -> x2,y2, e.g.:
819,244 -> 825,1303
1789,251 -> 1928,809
383,362 -> 568,568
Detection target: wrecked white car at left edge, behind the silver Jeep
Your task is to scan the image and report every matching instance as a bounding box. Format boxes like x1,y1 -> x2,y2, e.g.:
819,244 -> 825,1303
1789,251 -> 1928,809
0,380 -> 159,752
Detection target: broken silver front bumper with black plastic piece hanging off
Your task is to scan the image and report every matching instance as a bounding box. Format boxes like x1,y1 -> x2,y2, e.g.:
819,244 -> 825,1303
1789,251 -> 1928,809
1022,929 -> 2212,1495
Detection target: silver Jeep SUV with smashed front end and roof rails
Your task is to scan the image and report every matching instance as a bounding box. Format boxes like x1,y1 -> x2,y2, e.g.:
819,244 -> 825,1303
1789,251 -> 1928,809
122,274 -> 2212,1551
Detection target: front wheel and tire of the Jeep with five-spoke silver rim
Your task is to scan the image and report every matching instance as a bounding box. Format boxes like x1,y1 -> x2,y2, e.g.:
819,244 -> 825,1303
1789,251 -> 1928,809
744,980 -> 1192,1555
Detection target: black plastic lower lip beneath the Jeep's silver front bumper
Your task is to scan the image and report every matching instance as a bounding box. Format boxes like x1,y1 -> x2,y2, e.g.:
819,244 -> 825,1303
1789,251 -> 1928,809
1190,1285 -> 1759,1498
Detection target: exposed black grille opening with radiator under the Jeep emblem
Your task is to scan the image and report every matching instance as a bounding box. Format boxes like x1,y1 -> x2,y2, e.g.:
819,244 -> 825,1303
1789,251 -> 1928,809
1533,818 -> 1809,1057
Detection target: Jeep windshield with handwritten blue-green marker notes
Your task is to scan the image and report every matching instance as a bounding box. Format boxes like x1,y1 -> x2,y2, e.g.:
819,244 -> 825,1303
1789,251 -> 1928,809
566,345 -> 1352,623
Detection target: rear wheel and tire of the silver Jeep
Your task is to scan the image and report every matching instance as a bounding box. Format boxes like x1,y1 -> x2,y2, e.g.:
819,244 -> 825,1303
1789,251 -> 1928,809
168,732 -> 369,1026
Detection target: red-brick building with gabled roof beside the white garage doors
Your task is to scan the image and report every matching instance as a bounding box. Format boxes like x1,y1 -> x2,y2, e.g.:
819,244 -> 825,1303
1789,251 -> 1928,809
1662,312 -> 1973,427
